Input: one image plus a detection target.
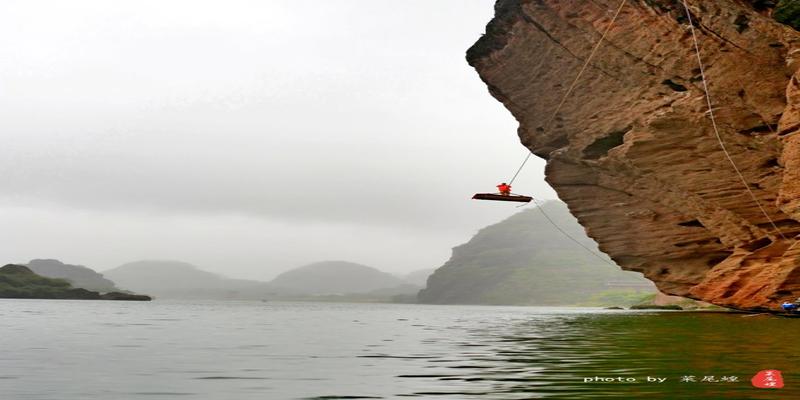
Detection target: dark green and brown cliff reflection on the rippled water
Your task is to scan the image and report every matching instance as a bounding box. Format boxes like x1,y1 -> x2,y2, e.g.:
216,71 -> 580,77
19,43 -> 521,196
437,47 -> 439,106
404,313 -> 800,399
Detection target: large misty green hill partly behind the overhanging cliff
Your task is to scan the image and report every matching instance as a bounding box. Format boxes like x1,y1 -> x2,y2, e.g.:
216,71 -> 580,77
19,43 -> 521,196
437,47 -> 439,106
418,201 -> 655,305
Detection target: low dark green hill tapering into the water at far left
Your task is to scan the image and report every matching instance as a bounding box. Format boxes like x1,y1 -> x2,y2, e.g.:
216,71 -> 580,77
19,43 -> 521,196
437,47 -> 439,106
0,264 -> 150,300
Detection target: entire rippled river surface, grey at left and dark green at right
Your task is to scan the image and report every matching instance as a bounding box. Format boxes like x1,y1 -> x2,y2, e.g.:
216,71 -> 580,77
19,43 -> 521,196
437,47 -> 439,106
0,300 -> 800,400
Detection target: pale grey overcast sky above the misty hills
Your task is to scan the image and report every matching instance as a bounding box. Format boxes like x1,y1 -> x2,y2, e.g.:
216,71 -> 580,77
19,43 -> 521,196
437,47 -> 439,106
0,0 -> 555,280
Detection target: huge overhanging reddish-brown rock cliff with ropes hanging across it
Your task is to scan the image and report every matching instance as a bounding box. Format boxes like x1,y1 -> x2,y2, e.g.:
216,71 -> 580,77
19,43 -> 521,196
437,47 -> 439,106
467,0 -> 800,309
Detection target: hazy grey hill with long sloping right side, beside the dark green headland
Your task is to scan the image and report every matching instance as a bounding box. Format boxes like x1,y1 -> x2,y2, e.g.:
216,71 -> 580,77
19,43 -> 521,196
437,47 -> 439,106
104,260 -> 268,299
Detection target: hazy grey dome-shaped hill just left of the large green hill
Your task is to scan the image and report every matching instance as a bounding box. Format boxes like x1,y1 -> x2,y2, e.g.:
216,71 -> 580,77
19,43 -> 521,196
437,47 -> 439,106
269,261 -> 408,295
